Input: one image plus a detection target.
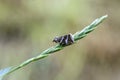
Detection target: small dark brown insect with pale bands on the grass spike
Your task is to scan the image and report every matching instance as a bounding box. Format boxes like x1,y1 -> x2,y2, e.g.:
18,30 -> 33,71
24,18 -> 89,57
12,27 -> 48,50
53,33 -> 74,46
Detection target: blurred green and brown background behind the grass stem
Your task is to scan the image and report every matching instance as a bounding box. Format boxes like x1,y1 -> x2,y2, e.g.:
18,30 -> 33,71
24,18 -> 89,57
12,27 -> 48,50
0,0 -> 120,80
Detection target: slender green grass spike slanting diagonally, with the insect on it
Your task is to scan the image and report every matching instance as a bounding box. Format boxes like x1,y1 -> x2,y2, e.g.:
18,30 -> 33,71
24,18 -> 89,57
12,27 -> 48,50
0,15 -> 107,80
